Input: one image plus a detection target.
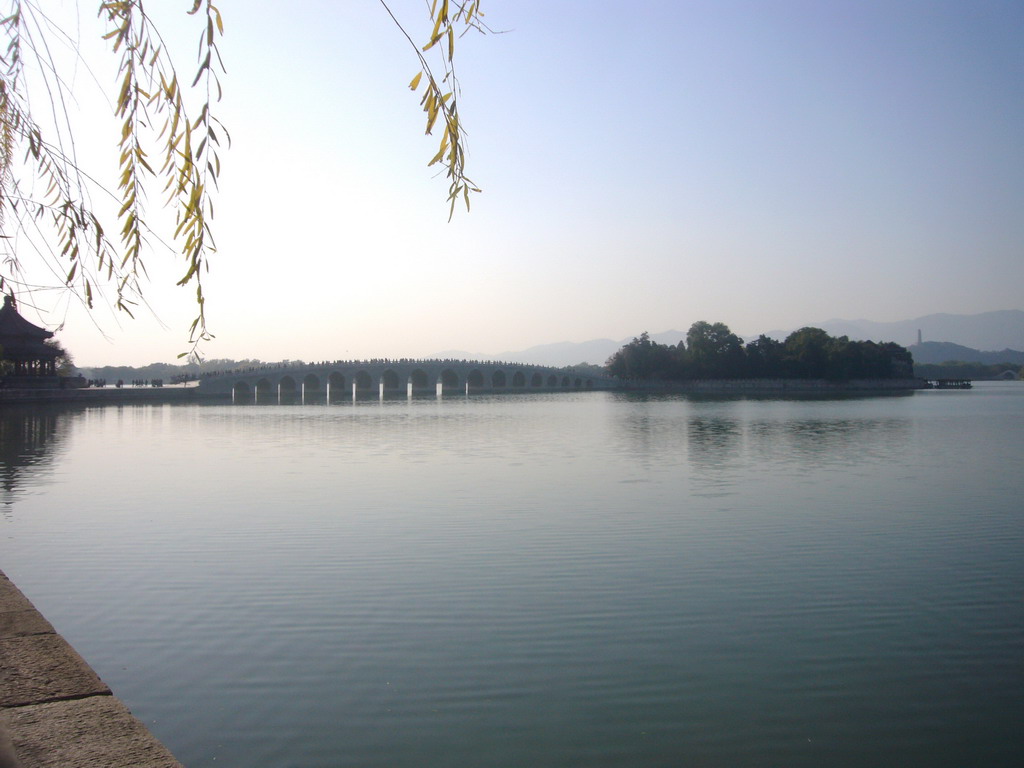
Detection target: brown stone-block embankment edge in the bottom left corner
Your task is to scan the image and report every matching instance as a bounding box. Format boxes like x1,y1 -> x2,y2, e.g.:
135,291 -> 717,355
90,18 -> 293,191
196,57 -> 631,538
0,571 -> 181,768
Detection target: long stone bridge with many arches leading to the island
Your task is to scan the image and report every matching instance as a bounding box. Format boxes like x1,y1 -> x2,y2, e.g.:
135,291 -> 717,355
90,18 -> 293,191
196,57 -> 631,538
199,359 -> 617,403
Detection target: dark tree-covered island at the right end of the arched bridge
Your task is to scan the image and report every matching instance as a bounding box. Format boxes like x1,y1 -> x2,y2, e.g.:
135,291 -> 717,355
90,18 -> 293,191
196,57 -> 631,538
605,321 -> 913,382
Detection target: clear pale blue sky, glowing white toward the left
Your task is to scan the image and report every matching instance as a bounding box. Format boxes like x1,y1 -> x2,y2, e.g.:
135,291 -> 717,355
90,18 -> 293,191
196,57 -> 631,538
9,0 -> 1024,367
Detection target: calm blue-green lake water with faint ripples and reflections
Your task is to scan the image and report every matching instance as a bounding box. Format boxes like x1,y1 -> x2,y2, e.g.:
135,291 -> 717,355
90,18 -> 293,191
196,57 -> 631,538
0,382 -> 1024,768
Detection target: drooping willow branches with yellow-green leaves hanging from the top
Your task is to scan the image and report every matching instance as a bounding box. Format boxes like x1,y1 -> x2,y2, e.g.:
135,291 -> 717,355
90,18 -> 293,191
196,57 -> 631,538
0,0 -> 486,348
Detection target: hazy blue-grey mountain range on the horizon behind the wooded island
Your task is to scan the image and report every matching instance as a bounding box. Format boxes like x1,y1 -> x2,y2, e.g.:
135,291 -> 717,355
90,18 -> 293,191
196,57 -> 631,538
437,309 -> 1024,367
